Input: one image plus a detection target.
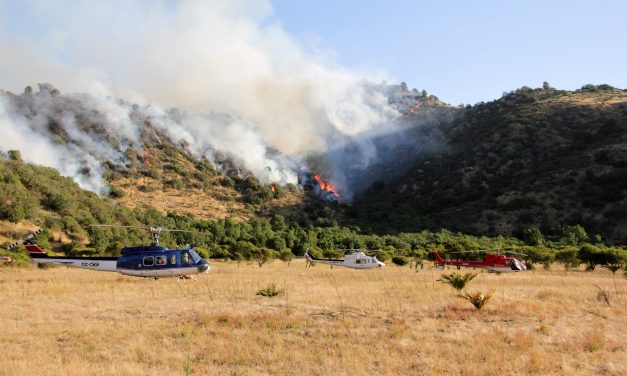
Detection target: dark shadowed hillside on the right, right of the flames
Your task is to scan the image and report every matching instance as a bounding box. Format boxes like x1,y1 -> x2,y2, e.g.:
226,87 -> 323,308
348,85 -> 627,242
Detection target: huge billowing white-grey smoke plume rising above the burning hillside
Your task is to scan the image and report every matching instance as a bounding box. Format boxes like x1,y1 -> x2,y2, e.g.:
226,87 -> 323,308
0,0 -> 446,197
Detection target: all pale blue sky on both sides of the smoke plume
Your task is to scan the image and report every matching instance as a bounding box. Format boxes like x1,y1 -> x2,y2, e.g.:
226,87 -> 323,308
0,0 -> 627,105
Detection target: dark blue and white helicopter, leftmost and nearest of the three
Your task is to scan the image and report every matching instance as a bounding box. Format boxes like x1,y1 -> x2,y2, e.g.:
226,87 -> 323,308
9,225 -> 210,279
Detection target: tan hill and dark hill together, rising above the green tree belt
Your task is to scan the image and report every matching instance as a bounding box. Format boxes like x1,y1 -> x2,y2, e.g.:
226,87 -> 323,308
5,85 -> 627,243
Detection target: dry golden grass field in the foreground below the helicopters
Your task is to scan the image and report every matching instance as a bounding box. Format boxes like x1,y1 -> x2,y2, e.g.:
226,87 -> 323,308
0,260 -> 627,375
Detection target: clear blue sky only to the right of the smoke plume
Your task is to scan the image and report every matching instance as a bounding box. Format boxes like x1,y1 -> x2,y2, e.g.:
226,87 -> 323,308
272,0 -> 627,104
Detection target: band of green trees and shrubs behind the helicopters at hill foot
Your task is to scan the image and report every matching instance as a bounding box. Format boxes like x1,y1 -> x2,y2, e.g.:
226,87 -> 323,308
0,154 -> 627,270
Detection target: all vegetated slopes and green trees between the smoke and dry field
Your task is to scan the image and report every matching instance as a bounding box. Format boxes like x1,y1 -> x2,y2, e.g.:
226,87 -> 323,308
0,83 -> 626,269
